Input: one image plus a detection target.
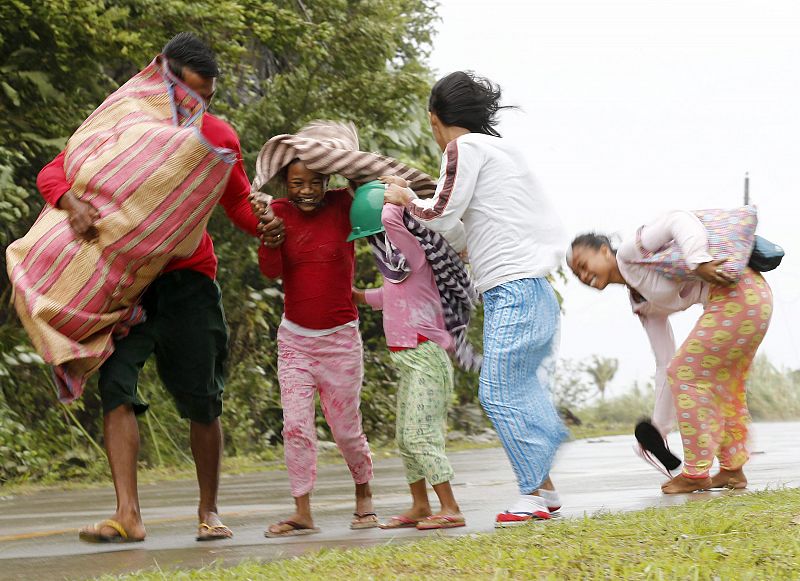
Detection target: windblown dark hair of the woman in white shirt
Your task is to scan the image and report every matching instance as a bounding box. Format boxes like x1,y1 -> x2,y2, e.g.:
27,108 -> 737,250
428,71 -> 515,137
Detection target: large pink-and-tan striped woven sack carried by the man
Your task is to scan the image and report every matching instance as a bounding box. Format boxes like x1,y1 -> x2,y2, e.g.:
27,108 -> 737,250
6,56 -> 236,402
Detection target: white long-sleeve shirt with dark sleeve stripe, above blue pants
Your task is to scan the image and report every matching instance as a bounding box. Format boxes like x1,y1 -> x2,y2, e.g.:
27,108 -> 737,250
409,133 -> 567,293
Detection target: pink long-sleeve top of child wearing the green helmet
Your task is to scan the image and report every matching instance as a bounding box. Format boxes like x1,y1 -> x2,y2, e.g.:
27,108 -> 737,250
364,204 -> 453,350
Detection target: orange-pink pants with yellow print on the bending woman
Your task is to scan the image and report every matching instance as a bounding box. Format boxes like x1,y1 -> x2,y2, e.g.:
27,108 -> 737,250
667,268 -> 772,478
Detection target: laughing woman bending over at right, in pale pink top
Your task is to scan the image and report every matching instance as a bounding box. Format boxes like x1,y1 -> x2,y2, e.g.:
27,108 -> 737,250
568,211 -> 772,494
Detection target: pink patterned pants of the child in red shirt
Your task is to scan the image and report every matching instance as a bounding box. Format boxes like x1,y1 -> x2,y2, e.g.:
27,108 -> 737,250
278,327 -> 372,498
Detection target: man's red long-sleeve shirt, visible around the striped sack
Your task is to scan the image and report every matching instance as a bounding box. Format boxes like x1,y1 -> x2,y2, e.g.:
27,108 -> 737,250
36,113 -> 258,278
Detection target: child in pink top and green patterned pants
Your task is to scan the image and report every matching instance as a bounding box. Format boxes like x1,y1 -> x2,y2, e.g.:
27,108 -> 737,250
350,201 -> 465,530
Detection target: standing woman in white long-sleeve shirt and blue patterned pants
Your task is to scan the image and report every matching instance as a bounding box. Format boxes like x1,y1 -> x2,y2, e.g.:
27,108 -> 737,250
386,72 -> 567,527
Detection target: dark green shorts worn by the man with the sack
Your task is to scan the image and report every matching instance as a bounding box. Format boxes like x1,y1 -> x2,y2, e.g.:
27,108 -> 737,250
99,270 -> 228,424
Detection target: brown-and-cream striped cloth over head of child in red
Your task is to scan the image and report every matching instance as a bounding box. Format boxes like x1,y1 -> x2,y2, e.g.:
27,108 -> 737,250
251,121 -> 436,196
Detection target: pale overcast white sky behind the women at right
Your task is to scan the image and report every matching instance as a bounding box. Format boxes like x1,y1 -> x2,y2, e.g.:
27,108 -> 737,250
431,0 -> 800,392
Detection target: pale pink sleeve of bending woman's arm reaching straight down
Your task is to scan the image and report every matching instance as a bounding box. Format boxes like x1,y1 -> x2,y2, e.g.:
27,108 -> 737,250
639,315 -> 676,436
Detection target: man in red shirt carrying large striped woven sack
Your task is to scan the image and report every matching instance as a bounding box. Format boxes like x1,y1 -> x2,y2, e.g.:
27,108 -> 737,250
8,33 -> 258,542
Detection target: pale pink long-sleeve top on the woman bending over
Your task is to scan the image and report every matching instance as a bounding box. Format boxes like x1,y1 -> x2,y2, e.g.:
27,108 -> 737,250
617,211 -> 713,434
